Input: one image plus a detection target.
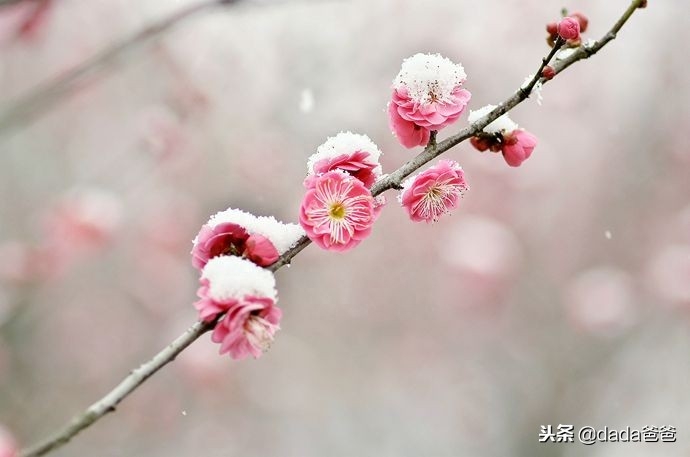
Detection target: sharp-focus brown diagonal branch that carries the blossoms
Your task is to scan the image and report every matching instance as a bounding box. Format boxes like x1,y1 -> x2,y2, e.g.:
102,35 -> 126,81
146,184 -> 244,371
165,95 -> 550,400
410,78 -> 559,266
20,0 -> 644,457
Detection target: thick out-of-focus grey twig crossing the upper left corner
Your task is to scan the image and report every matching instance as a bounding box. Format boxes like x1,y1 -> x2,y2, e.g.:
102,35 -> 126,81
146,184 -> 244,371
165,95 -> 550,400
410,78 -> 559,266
0,0 -> 239,134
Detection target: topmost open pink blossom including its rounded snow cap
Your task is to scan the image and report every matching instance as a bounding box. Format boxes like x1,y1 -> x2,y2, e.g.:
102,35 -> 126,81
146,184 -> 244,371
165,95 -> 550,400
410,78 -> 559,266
388,53 -> 471,147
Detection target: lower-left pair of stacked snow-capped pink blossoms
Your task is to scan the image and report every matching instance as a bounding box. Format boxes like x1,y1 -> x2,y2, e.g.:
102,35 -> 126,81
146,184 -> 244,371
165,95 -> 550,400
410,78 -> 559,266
192,208 -> 304,360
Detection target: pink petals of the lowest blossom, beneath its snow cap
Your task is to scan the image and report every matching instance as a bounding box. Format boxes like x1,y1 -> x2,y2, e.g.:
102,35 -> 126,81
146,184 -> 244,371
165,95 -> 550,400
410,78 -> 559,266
211,296 -> 283,360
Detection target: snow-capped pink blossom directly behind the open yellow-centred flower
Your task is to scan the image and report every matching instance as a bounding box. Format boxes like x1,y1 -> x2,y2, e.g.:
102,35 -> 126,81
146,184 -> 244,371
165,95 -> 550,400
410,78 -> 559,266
307,132 -> 381,187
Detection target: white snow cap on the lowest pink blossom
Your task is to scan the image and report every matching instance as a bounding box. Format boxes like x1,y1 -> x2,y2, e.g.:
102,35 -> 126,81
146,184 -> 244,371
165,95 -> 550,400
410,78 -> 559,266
201,256 -> 278,301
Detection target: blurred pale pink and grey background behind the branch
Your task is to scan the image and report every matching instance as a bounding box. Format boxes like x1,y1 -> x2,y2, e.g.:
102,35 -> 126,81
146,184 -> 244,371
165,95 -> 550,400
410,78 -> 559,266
0,0 -> 690,457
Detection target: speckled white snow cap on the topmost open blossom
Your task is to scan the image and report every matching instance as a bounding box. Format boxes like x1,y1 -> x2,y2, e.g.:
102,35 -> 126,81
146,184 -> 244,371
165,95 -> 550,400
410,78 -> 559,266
393,53 -> 467,105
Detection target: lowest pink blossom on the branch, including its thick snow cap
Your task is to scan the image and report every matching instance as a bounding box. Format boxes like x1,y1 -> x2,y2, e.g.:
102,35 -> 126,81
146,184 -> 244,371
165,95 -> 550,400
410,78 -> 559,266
194,256 -> 282,360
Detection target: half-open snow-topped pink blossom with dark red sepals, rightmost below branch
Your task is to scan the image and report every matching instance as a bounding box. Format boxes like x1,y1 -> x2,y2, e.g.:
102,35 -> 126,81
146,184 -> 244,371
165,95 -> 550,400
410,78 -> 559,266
467,105 -> 538,167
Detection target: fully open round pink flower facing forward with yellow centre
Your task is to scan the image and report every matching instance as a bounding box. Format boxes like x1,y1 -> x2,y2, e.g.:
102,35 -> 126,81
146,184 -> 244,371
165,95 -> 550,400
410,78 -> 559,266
299,171 -> 376,251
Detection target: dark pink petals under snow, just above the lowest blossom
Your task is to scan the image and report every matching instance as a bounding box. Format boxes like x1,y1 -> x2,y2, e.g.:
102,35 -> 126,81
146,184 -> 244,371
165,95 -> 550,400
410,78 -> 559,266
192,222 -> 280,269
